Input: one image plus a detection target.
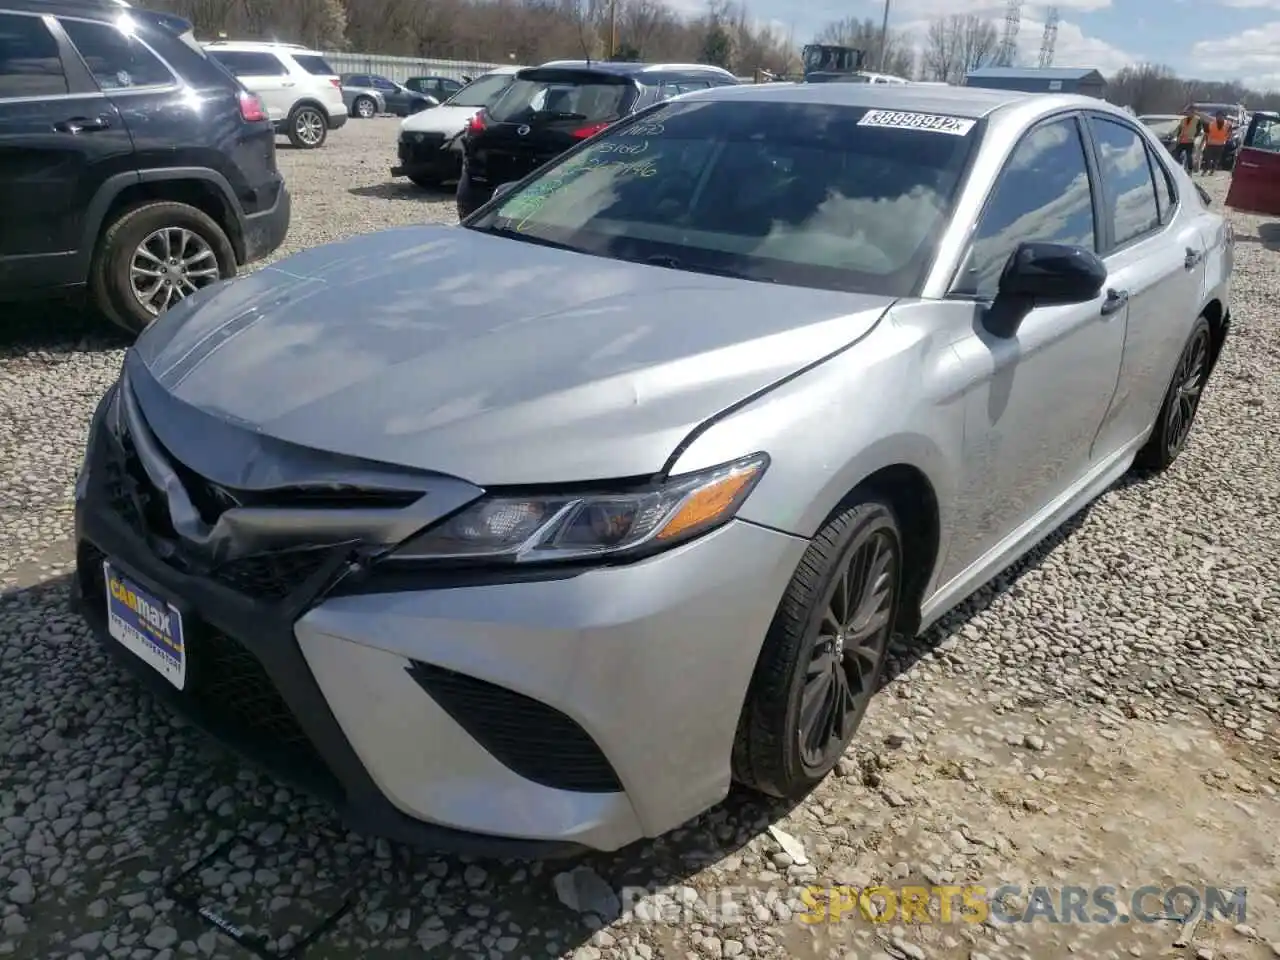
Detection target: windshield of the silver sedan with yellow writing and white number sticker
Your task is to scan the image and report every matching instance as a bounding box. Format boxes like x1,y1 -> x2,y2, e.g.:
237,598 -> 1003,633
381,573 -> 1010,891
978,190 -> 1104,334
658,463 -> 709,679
467,100 -> 978,297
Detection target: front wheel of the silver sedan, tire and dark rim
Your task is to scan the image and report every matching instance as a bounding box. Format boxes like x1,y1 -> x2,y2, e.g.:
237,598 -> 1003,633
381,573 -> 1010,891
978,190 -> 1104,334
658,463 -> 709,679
733,498 -> 902,799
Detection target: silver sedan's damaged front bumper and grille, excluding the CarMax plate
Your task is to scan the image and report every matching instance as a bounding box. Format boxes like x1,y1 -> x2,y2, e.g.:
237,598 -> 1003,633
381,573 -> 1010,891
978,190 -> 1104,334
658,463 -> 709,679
74,352 -> 808,858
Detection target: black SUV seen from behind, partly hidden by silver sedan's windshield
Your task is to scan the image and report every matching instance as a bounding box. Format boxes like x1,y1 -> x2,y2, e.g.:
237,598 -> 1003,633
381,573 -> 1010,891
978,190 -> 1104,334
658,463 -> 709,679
457,60 -> 739,218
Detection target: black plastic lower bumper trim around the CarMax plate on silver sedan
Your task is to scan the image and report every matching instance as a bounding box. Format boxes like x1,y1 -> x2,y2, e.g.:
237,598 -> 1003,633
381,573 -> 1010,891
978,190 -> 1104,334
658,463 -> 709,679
72,463 -> 586,859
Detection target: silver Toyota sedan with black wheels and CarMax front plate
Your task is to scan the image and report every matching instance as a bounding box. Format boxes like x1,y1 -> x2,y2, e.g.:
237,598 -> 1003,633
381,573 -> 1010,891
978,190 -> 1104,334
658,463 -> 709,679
77,83 -> 1233,855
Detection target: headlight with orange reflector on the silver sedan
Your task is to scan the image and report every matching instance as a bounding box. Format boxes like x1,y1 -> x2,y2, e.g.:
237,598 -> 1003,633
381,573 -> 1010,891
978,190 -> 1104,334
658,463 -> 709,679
390,453 -> 769,563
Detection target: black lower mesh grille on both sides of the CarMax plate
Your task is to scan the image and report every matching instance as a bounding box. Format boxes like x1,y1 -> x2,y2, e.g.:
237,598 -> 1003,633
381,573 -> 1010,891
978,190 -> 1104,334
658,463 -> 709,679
77,541 -> 335,788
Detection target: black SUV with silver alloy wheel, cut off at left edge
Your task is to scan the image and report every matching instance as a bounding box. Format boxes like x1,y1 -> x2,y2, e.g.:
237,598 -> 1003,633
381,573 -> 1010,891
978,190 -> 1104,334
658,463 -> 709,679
0,0 -> 291,333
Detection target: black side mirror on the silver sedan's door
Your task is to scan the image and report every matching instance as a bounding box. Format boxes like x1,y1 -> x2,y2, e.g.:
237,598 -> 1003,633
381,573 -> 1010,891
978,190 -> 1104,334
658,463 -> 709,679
986,241 -> 1107,337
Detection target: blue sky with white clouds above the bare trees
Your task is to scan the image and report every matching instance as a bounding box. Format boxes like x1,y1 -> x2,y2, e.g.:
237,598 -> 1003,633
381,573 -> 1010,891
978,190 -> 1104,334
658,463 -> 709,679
672,0 -> 1280,91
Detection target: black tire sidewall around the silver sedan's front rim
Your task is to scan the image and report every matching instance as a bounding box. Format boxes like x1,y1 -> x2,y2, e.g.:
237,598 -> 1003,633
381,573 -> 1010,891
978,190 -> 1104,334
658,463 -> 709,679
782,500 -> 904,781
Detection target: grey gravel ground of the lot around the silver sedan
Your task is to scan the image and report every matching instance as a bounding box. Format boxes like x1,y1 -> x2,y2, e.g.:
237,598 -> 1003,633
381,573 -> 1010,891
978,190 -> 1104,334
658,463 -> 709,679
0,120 -> 1280,960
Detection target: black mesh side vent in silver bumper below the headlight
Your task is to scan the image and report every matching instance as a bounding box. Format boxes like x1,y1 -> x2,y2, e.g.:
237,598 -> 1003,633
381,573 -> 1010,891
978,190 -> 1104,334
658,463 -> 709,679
408,660 -> 622,794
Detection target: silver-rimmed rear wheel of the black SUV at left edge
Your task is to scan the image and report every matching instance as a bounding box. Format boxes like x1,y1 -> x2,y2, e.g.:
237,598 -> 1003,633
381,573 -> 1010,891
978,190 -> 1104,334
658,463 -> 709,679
90,201 -> 236,335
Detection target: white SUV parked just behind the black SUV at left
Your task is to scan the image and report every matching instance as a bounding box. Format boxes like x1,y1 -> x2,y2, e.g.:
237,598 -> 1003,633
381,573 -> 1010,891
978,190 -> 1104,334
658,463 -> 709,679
204,40 -> 347,150
